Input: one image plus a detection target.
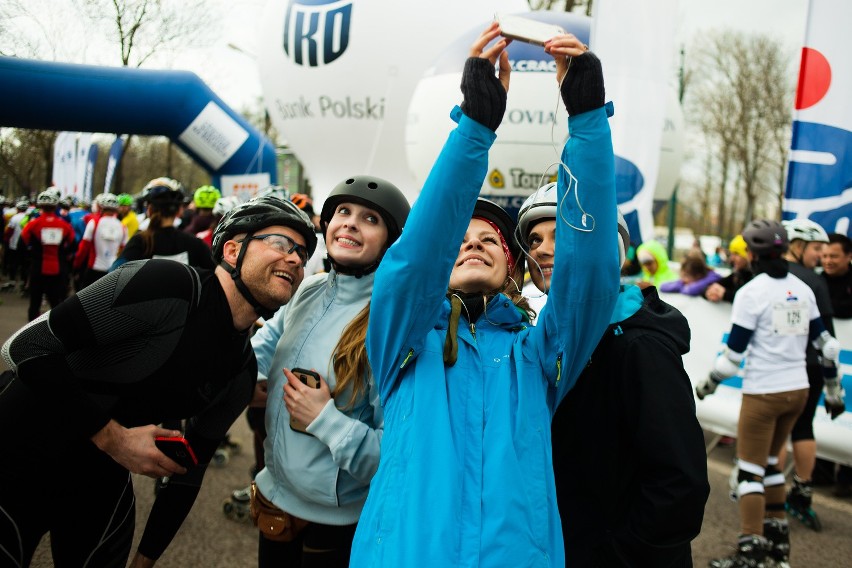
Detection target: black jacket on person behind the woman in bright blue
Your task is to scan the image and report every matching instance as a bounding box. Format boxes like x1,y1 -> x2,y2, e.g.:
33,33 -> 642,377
552,287 -> 710,568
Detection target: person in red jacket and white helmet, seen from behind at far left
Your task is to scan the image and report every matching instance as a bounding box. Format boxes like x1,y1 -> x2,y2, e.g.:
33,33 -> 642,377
21,187 -> 75,321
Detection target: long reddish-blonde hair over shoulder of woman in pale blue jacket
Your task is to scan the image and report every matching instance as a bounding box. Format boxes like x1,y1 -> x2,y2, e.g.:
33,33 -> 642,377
331,302 -> 370,409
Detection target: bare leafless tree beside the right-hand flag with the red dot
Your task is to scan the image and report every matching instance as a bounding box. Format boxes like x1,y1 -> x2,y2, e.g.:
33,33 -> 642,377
687,32 -> 793,237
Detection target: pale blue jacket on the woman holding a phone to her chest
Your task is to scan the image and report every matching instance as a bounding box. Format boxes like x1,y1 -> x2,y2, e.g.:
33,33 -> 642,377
252,270 -> 382,525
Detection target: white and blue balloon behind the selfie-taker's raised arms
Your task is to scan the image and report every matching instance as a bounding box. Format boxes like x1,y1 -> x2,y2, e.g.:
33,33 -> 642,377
406,12 -> 683,220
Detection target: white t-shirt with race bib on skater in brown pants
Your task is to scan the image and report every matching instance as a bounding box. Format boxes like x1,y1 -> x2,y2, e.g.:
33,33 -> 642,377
731,274 -> 819,394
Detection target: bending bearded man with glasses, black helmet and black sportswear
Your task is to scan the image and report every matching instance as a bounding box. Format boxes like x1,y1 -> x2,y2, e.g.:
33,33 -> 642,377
0,193 -> 316,568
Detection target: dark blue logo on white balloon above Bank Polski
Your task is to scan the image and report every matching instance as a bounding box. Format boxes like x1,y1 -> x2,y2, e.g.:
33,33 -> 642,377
284,0 -> 352,67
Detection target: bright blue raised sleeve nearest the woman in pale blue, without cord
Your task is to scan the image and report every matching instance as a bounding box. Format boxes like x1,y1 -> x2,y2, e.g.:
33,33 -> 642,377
366,107 -> 500,402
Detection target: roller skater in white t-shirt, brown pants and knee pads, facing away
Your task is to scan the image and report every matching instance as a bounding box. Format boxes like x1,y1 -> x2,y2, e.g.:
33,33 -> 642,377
696,220 -> 843,568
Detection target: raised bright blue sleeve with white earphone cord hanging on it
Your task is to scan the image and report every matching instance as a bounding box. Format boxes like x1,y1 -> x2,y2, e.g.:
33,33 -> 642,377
530,103 -> 620,403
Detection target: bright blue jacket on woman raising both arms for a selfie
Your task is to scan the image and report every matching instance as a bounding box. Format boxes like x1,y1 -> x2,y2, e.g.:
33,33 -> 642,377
351,107 -> 619,568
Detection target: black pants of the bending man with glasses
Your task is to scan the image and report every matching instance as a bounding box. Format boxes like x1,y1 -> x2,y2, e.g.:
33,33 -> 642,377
0,374 -> 136,568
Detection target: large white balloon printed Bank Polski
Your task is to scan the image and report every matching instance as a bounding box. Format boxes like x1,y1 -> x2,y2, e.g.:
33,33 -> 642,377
259,0 -> 528,209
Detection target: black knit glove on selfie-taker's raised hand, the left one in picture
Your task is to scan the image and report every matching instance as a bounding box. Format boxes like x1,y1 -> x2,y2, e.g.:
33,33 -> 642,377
461,57 -> 506,130
